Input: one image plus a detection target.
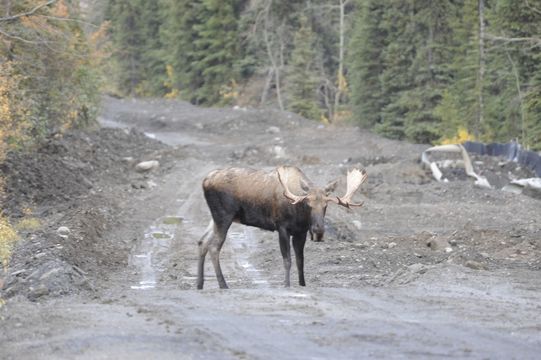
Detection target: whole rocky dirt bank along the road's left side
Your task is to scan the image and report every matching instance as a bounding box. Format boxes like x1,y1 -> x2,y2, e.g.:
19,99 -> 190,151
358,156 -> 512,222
0,129 -> 180,299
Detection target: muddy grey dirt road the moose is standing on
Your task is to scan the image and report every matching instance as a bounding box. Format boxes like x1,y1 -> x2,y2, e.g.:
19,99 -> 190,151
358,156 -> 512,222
0,99 -> 541,359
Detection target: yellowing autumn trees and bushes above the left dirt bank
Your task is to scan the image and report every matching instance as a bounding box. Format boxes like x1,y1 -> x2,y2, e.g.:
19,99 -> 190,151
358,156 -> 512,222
0,0 -> 99,152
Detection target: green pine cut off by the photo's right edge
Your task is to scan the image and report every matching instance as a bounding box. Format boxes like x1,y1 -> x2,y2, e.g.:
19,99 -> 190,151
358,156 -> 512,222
490,0 -> 541,149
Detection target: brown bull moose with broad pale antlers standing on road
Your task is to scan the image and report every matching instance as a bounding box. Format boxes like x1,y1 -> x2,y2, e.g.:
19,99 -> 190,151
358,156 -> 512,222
197,166 -> 367,289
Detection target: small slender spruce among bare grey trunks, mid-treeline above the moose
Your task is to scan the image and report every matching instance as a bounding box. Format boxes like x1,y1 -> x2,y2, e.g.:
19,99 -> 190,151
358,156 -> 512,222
286,17 -> 321,119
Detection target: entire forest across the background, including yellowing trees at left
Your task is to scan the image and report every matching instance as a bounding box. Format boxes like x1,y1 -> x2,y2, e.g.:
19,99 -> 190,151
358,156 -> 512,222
0,0 -> 541,154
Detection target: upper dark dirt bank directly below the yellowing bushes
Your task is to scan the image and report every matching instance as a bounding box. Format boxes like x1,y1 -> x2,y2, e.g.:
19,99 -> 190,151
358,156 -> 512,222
0,129 -> 165,217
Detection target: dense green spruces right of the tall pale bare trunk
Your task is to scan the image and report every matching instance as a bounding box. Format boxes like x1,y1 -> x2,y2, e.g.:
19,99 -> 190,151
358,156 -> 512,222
348,0 -> 541,149
